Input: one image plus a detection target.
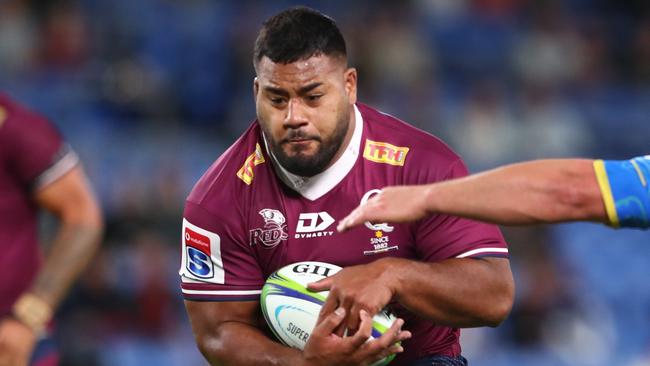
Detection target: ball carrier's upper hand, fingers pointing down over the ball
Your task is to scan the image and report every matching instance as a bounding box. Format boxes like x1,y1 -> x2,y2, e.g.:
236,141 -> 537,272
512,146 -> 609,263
307,260 -> 396,335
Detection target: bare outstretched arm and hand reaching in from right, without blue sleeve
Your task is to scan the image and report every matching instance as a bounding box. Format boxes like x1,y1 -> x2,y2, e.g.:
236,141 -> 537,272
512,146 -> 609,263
338,159 -> 611,231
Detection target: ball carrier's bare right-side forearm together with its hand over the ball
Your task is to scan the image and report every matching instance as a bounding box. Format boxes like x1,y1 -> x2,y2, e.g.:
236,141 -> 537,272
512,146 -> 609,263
309,258 -> 514,329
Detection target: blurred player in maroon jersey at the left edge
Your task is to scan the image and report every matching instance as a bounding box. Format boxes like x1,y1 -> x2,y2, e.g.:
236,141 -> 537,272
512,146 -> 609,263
0,94 -> 102,366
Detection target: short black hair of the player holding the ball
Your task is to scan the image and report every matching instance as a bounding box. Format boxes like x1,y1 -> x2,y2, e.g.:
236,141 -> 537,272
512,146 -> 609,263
253,6 -> 347,68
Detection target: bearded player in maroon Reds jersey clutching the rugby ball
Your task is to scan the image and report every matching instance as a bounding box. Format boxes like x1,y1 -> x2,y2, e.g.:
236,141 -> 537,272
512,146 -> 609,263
180,7 -> 514,366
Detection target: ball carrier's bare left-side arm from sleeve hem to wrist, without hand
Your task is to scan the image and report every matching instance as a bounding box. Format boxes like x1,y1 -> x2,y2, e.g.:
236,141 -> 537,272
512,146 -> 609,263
185,300 -> 301,366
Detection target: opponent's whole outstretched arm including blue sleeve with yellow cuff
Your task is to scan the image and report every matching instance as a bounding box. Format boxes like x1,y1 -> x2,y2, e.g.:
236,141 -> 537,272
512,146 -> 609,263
338,156 -> 650,231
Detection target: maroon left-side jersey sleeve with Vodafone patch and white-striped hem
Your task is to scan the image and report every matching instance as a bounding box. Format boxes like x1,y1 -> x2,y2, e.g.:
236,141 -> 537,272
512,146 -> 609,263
179,200 -> 264,301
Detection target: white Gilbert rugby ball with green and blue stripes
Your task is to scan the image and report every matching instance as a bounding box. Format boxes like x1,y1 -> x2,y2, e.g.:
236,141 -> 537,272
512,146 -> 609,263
260,261 -> 397,366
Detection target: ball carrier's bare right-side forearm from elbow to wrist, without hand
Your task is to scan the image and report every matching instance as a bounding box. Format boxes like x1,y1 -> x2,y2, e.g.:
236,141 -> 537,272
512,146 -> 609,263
382,258 -> 514,327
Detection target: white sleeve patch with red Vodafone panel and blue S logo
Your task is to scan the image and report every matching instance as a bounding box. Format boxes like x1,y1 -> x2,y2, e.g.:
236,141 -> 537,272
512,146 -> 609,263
179,219 -> 225,284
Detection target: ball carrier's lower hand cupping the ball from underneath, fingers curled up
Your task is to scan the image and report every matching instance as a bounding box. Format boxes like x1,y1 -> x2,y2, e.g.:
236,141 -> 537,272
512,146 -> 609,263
303,308 -> 411,366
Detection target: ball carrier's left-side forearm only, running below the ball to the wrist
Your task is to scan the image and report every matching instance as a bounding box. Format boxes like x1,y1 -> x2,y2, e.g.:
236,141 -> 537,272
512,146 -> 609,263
196,321 -> 304,366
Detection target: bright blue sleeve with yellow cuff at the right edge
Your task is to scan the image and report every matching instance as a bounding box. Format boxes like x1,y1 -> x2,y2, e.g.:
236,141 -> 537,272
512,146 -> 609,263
594,155 -> 650,228
